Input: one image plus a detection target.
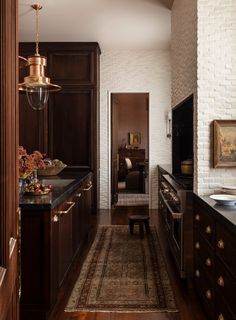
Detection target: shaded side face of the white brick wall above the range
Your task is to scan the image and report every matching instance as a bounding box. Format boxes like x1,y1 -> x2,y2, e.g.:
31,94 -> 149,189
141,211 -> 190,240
171,0 -> 198,190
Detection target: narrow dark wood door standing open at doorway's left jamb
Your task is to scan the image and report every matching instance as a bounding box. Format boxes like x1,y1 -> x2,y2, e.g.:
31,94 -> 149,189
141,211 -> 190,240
111,94 -> 119,204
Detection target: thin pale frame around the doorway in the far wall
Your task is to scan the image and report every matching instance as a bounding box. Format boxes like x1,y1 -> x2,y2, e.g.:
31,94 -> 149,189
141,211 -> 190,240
107,90 -> 151,209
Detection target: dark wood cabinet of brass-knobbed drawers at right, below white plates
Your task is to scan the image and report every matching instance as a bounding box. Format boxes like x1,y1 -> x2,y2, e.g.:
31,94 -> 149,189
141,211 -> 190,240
194,196 -> 236,320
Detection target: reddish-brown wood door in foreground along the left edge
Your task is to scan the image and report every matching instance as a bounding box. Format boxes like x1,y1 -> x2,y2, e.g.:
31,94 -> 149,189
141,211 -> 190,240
0,0 -> 19,320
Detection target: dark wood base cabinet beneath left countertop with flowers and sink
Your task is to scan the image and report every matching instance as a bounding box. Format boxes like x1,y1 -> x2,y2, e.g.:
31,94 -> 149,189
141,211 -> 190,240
20,174 -> 96,320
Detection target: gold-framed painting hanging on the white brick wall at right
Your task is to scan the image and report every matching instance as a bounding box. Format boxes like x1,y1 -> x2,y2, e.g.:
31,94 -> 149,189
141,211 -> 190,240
213,120 -> 236,168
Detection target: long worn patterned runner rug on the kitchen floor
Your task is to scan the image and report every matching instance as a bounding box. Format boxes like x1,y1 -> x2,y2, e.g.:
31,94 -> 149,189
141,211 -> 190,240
65,226 -> 177,312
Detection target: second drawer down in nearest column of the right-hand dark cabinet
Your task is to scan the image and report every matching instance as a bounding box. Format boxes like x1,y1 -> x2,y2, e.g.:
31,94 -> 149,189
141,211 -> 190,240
215,258 -> 236,315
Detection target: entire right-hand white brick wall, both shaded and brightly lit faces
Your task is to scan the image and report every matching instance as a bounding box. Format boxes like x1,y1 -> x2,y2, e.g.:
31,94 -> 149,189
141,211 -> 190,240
171,0 -> 236,195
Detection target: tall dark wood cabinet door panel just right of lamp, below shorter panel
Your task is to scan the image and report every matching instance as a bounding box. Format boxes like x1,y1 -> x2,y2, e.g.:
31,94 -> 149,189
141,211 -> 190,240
49,90 -> 94,169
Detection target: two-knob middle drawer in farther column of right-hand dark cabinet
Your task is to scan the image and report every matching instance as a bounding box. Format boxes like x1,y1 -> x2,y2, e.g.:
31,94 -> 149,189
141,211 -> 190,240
194,233 -> 215,278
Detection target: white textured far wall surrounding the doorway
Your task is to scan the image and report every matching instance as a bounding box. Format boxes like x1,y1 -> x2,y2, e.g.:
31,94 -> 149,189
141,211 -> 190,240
99,50 -> 171,209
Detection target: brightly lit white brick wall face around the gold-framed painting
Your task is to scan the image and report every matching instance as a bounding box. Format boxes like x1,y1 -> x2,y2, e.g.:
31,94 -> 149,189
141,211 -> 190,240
197,0 -> 236,194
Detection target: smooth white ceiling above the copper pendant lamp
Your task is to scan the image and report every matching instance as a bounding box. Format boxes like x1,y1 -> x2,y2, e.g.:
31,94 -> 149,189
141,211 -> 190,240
19,0 -> 170,50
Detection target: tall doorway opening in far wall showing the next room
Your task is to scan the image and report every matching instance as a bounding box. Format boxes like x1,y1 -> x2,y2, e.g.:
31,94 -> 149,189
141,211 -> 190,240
111,92 -> 149,207
